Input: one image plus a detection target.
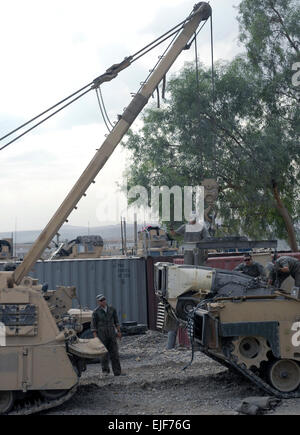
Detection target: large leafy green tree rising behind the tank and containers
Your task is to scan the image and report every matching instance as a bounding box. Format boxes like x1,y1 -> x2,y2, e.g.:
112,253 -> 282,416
122,0 -> 300,250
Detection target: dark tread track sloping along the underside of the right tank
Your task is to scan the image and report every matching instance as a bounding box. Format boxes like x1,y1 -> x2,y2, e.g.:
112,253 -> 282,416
201,346 -> 300,399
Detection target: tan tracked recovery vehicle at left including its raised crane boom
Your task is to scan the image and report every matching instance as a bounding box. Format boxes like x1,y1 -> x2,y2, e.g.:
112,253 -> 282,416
0,2 -> 211,414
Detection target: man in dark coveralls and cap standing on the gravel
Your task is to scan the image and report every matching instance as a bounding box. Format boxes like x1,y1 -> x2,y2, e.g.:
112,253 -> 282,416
91,294 -> 124,376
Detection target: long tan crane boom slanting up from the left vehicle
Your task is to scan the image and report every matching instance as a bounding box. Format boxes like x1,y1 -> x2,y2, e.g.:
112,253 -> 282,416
13,2 -> 211,285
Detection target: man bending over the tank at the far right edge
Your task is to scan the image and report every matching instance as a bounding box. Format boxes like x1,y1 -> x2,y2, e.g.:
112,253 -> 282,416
268,256 -> 300,288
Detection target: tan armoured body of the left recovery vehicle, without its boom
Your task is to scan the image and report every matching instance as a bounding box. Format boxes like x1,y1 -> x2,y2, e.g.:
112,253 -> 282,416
0,272 -> 106,414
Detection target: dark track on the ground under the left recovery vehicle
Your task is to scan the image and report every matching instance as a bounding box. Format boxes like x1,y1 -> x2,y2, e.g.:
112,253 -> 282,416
6,385 -> 78,415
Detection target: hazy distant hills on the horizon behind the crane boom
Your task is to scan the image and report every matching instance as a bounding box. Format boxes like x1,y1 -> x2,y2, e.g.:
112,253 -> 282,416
0,224 -> 142,243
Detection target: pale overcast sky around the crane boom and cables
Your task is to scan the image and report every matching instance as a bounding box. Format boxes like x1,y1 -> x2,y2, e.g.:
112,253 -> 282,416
0,0 -> 242,232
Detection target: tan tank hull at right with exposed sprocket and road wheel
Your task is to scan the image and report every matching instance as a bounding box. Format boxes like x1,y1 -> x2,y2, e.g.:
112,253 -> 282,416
189,300 -> 300,398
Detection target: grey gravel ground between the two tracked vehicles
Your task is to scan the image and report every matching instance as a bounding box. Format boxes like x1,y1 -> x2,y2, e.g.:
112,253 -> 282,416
44,331 -> 300,416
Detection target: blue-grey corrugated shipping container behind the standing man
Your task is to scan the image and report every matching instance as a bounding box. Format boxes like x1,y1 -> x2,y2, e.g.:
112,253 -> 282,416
31,258 -> 148,325
